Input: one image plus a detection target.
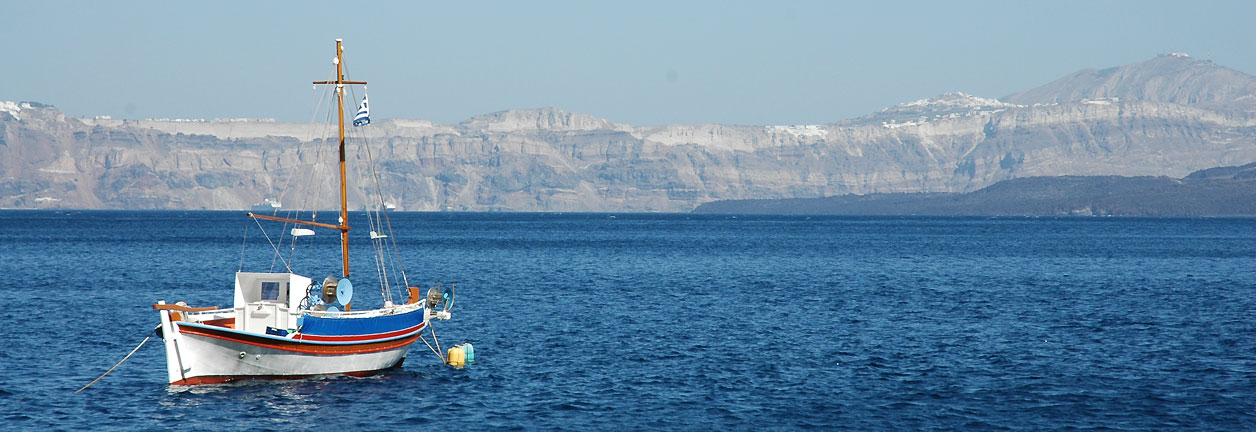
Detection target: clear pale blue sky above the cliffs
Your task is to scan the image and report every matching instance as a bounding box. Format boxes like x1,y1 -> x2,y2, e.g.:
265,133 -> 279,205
0,0 -> 1256,126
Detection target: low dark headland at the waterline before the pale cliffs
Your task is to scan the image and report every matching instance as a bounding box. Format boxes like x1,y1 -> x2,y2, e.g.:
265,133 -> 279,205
693,163 -> 1256,216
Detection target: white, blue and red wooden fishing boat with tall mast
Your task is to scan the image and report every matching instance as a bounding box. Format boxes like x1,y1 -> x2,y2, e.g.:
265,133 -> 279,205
153,39 -> 453,386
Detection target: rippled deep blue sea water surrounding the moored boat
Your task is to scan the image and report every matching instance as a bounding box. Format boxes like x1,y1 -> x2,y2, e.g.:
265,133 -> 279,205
0,211 -> 1256,431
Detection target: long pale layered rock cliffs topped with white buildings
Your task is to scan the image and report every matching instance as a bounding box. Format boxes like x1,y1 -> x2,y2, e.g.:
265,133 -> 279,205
0,57 -> 1256,211
